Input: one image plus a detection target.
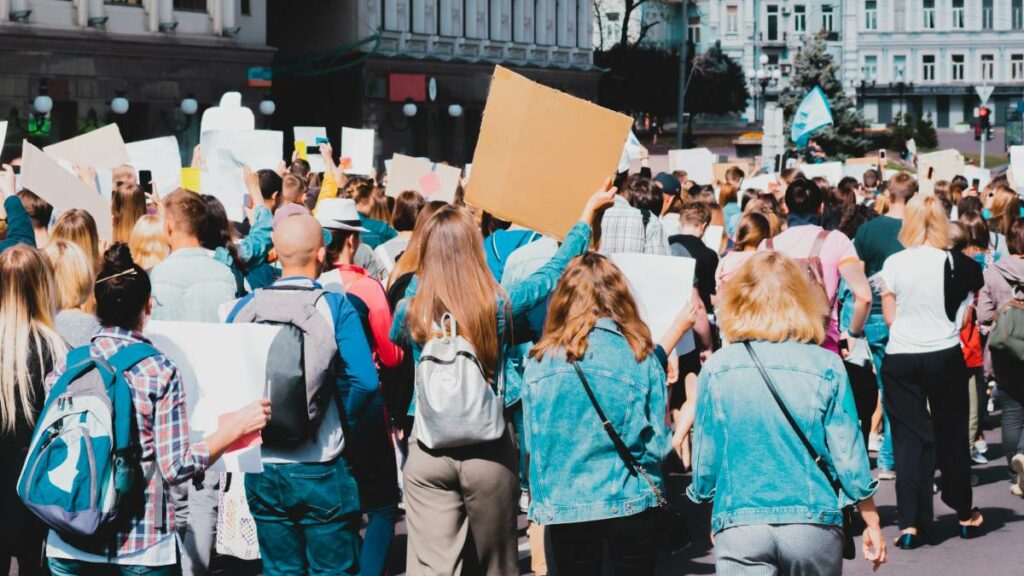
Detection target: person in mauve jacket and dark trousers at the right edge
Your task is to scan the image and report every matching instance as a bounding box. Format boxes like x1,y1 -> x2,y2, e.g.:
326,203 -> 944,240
978,218 -> 1024,497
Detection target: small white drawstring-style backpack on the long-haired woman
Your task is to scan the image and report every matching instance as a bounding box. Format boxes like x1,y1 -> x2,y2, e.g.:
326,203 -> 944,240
413,314 -> 505,449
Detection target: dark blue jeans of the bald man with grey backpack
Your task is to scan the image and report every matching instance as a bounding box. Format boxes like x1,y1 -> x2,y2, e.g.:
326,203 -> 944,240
246,457 -> 361,576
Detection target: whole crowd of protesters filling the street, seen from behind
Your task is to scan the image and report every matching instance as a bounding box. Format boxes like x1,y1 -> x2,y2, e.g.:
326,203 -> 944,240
0,139 -> 1024,576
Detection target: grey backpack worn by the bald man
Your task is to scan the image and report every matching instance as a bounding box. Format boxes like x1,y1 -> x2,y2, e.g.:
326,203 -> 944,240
233,286 -> 340,446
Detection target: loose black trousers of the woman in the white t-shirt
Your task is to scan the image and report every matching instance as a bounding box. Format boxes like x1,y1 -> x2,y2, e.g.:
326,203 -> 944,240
882,346 -> 973,530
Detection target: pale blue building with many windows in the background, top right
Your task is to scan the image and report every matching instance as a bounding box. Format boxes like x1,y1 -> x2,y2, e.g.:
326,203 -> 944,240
630,0 -> 1024,128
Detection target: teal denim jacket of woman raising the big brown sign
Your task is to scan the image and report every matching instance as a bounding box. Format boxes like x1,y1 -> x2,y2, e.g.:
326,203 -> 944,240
390,217 -> 591,409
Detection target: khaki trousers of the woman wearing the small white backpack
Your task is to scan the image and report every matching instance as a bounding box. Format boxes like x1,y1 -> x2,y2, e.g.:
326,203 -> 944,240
403,434 -> 519,576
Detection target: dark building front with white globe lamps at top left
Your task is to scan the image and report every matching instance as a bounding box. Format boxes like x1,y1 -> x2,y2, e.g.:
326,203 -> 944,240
0,0 -> 273,160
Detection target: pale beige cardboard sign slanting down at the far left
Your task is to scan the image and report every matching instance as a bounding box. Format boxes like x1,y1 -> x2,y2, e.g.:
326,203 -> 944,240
22,140 -> 114,241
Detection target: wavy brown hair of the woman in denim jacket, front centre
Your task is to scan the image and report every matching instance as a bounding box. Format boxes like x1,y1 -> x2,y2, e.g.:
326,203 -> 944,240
529,252 -> 654,362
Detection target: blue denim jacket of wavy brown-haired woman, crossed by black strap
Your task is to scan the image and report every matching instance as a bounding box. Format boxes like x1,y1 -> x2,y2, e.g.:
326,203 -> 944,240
522,318 -> 671,524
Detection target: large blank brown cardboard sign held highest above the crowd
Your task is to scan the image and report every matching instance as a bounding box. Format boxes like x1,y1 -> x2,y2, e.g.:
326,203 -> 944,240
466,67 -> 633,239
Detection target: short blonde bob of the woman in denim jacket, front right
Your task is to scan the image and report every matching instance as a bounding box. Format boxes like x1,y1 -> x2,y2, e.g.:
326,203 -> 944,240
716,251 -> 829,344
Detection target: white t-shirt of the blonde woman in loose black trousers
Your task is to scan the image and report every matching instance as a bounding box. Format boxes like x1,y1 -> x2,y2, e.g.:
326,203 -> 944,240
878,246 -> 959,354
